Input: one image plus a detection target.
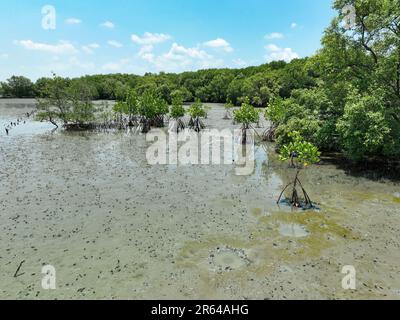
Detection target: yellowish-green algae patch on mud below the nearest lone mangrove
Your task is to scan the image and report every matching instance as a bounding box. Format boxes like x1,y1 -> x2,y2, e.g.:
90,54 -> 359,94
177,209 -> 357,272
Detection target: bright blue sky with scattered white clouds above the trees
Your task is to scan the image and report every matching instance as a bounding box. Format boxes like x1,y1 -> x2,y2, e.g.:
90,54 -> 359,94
0,0 -> 334,81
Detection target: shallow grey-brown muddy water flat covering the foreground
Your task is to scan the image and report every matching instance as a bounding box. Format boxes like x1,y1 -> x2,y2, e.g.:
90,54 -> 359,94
0,100 -> 400,299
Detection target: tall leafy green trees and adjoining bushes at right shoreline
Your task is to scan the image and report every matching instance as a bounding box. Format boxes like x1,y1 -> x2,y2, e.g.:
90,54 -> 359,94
266,0 -> 400,161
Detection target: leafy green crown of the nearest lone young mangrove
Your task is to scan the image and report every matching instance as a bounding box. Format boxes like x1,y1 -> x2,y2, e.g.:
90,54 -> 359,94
279,131 -> 321,166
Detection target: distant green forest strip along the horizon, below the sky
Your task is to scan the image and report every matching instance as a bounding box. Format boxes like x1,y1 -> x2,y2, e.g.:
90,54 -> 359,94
0,57 -> 316,107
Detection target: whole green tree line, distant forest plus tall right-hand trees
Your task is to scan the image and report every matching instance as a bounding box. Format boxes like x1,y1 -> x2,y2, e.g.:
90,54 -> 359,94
1,0 -> 400,160
